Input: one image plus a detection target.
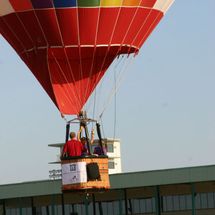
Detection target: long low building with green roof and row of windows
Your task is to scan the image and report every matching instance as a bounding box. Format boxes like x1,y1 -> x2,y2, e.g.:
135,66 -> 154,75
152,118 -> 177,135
0,165 -> 215,215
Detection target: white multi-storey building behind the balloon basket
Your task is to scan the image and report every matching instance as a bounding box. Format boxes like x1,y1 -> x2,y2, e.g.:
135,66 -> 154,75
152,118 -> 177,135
49,138 -> 122,174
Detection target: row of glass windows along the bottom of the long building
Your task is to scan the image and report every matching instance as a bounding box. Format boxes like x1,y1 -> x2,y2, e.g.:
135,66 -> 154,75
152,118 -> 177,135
0,192 -> 215,215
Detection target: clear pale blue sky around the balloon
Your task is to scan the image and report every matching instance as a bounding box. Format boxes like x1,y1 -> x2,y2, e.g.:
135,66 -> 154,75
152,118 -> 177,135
0,0 -> 215,184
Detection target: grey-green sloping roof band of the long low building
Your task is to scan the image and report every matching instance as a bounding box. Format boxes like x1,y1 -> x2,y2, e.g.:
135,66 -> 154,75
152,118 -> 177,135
0,165 -> 215,199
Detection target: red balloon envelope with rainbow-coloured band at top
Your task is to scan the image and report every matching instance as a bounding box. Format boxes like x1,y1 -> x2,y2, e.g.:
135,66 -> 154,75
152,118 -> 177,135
0,0 -> 173,191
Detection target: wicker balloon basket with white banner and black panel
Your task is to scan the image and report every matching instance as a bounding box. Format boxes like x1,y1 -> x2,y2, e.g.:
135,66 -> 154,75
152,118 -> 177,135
61,156 -> 110,192
